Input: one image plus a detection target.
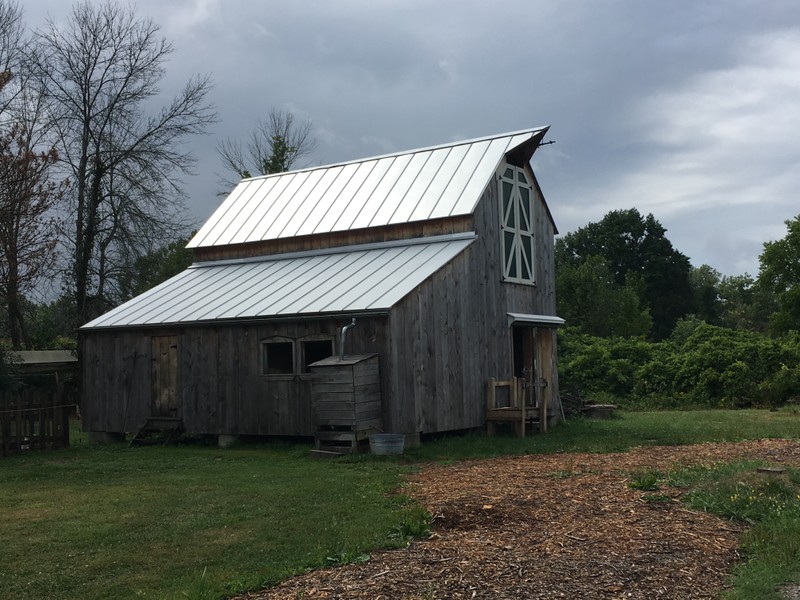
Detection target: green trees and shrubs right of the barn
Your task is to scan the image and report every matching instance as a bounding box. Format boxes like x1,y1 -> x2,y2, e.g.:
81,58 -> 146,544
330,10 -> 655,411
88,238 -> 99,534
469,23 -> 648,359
555,209 -> 800,408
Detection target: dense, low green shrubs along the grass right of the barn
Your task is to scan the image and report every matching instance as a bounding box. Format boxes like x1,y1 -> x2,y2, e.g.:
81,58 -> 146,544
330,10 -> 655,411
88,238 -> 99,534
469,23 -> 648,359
559,320 -> 800,409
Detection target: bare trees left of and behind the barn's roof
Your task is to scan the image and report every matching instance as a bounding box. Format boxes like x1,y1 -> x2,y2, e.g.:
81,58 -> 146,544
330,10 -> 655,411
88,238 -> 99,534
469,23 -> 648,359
0,0 -> 314,348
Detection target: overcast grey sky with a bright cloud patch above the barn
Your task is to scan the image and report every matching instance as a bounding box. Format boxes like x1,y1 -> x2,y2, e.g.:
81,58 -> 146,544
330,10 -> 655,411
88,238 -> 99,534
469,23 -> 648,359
21,0 -> 800,275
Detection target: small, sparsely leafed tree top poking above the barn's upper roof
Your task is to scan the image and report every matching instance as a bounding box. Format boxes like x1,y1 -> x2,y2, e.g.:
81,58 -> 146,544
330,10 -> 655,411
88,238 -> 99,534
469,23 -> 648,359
217,108 -> 317,189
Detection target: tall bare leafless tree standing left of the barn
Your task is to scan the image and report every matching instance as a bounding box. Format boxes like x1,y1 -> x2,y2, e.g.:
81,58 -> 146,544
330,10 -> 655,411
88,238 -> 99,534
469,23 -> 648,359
31,0 -> 216,322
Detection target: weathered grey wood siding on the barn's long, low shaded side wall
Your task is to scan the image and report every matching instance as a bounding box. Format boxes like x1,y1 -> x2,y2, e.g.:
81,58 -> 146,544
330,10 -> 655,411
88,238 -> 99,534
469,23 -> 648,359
82,317 -> 391,436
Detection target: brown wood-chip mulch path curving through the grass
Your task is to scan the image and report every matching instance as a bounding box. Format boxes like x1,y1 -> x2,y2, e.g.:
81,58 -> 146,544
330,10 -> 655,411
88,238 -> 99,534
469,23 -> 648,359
240,440 -> 800,600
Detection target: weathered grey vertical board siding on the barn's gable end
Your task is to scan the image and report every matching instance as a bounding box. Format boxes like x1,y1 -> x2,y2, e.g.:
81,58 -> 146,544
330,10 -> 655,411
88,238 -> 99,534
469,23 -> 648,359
384,170 -> 555,433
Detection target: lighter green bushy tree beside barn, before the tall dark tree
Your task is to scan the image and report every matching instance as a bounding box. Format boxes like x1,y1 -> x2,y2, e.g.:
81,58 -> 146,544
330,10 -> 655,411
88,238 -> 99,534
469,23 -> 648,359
556,256 -> 652,337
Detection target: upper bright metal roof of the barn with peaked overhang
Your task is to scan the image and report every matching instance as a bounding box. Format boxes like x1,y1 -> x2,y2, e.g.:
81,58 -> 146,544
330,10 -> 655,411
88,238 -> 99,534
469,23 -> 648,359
188,127 -> 547,248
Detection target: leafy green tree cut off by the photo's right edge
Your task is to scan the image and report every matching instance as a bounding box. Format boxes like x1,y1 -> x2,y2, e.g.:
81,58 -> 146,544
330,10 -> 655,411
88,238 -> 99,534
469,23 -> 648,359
758,215 -> 800,333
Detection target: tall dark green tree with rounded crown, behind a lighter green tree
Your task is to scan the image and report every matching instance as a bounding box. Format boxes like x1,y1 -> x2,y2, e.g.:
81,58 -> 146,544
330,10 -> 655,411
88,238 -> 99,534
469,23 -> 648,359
556,208 -> 695,339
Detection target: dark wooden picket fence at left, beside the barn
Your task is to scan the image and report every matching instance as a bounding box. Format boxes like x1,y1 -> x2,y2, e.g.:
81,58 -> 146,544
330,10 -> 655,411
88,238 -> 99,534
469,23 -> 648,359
0,387 -> 74,456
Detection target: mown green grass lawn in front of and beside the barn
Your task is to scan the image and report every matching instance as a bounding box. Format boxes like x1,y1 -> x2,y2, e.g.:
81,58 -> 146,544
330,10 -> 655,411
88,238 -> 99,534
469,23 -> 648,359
0,411 -> 800,600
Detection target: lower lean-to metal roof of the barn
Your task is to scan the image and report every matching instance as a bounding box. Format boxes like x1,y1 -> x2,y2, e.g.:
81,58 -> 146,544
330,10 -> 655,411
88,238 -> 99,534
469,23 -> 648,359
81,233 -> 475,329
